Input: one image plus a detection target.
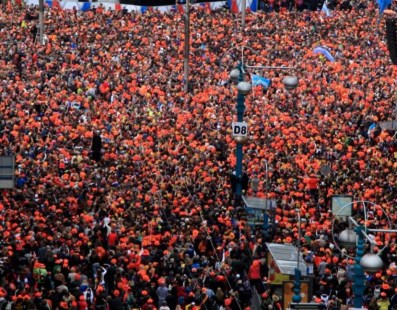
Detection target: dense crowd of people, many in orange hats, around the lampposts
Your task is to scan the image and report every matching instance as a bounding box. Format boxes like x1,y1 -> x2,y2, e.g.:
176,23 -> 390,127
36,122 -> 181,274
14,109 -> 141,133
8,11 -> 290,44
0,2 -> 397,310
